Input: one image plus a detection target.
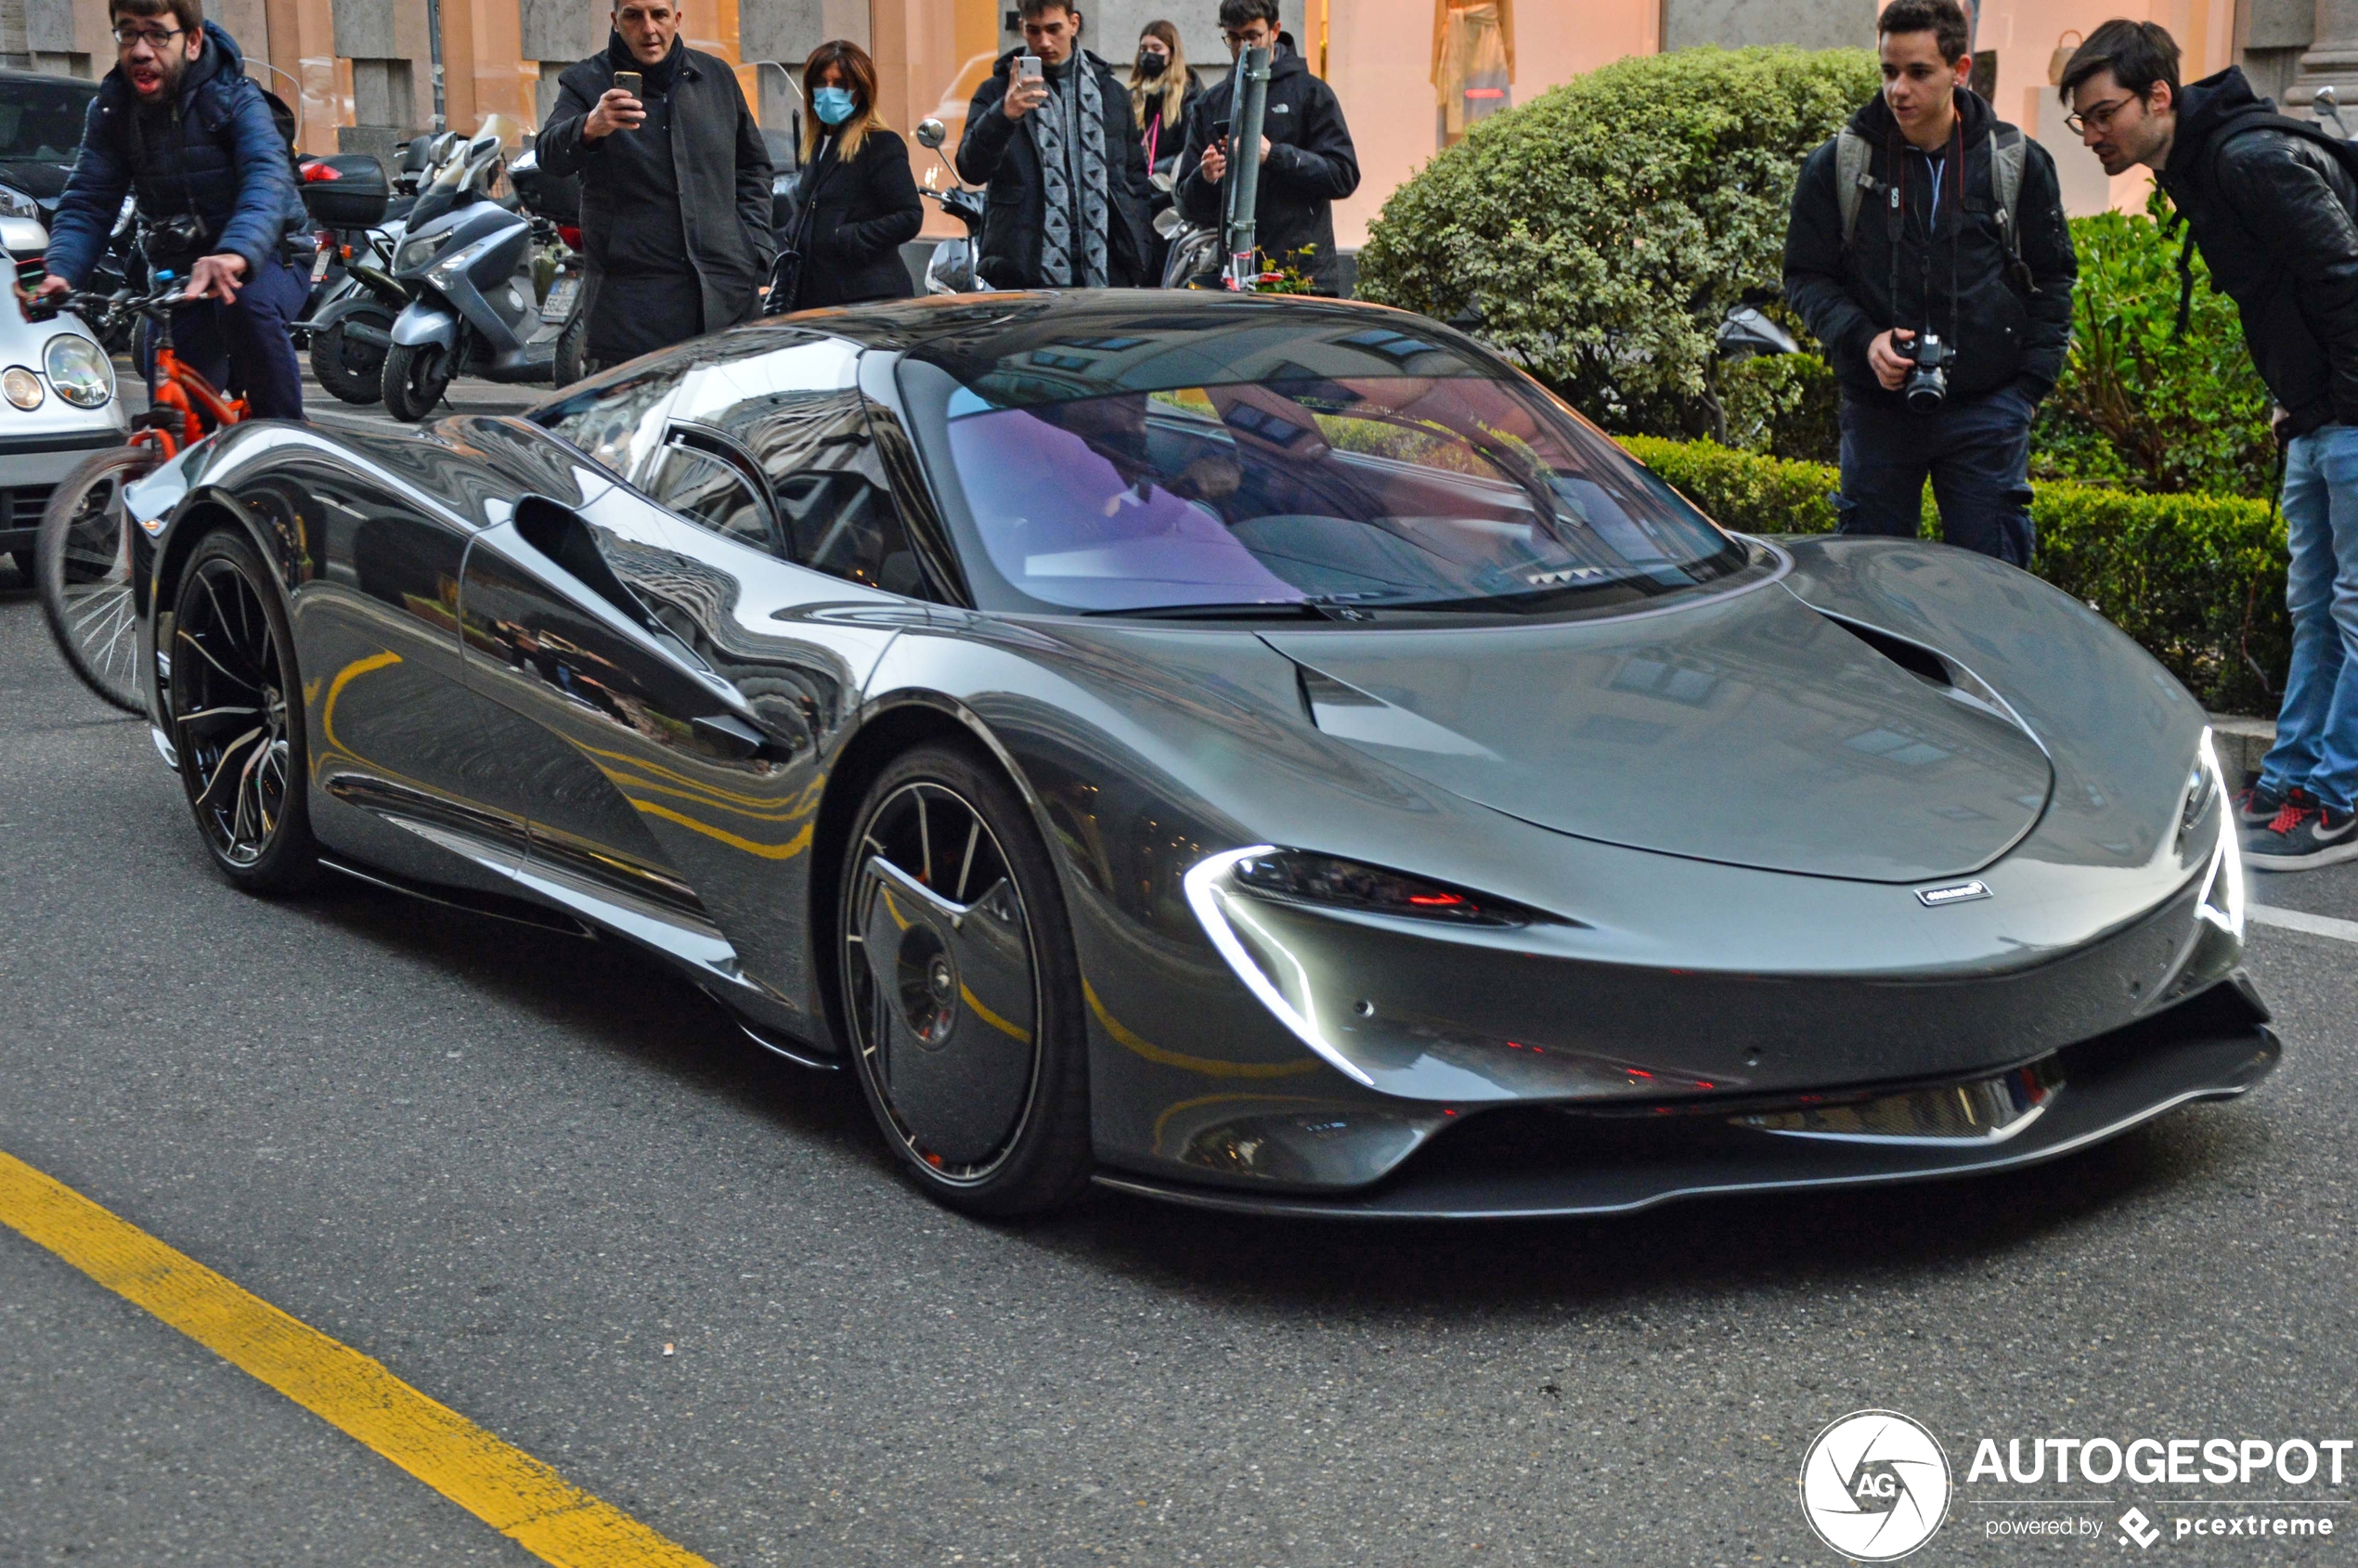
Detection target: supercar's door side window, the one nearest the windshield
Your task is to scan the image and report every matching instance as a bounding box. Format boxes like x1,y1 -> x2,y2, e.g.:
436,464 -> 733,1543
712,387 -> 925,597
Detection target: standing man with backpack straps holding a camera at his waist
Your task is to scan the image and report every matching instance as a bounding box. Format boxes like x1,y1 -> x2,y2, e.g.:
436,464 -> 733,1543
1785,0 -> 2079,566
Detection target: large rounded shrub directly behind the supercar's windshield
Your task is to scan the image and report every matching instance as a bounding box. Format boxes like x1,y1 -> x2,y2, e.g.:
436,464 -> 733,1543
1358,47 -> 1877,432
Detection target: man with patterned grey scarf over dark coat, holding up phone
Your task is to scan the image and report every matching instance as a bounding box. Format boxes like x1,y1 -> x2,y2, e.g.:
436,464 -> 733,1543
957,0 -> 1156,288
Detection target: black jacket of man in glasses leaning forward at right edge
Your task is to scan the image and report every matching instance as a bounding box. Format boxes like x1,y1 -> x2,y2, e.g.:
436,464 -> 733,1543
2160,66 -> 2358,436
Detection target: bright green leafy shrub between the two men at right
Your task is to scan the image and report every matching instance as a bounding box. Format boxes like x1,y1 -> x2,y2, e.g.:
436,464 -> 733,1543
2030,196 -> 2275,495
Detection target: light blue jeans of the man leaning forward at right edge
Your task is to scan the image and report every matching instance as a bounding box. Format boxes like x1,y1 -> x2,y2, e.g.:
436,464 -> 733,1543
2259,424 -> 2358,811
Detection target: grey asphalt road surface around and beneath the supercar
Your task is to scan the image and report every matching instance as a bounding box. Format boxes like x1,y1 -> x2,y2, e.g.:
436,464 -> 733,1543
0,535 -> 2358,1568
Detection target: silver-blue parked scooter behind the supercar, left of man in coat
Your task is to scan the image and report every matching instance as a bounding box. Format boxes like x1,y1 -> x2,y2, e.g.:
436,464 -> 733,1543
384,127 -> 556,422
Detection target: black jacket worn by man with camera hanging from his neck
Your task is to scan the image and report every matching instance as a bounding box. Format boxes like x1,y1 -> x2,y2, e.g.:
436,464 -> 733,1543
1785,90 -> 2079,408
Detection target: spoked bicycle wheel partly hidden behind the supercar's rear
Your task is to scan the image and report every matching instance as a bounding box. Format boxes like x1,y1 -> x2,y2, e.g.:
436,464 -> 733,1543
33,446 -> 156,712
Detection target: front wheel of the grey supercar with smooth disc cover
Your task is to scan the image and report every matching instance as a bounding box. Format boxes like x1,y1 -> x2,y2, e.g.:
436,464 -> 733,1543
835,745 -> 1092,1217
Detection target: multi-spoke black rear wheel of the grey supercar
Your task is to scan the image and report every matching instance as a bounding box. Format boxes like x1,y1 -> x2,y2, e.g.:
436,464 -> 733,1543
165,528 -> 318,894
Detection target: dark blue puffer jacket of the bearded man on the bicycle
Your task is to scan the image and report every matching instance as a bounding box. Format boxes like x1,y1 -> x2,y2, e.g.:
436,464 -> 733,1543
47,21 -> 302,288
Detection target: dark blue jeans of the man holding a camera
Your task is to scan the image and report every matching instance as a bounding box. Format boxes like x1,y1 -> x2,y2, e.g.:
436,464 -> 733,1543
1834,387 -> 2038,566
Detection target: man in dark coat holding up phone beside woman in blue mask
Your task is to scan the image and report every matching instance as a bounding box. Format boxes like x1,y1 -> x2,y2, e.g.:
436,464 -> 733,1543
536,0 -> 776,366
